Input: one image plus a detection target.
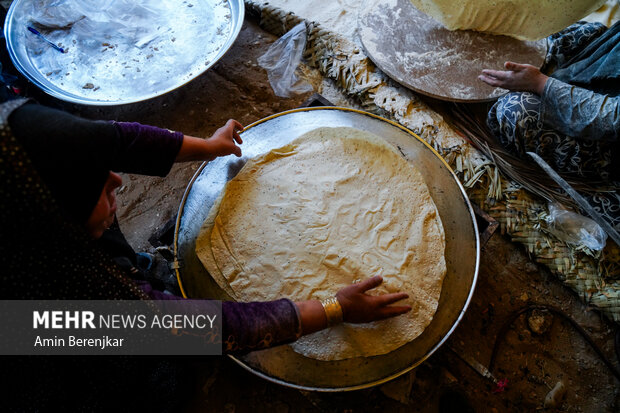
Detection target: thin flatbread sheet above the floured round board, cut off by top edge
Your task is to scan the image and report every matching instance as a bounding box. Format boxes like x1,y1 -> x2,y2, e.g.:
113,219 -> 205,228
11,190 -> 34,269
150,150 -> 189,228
411,0 -> 606,40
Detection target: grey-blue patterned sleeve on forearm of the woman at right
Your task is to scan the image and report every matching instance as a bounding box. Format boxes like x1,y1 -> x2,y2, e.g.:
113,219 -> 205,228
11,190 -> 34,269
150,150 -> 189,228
541,78 -> 620,141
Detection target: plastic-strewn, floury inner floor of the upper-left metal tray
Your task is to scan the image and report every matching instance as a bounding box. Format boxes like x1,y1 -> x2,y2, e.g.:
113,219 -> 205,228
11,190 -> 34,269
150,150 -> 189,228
17,0 -> 231,101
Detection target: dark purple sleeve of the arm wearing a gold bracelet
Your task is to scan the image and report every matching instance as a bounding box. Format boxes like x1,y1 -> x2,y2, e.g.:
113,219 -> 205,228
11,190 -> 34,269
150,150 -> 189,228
136,281 -> 301,353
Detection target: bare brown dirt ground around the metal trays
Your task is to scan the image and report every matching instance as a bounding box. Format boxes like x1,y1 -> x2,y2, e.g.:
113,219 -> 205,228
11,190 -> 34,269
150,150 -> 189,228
42,16 -> 620,413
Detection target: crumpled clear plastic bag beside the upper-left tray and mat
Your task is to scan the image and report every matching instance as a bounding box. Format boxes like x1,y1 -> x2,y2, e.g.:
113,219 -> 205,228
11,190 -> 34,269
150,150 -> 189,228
258,22 -> 313,98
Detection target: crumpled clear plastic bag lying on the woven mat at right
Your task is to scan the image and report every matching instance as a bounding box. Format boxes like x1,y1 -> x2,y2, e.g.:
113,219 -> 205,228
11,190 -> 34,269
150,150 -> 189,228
545,202 -> 607,251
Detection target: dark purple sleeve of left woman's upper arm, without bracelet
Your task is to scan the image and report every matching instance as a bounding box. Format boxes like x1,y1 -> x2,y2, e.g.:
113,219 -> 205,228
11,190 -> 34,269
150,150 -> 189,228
112,122 -> 183,176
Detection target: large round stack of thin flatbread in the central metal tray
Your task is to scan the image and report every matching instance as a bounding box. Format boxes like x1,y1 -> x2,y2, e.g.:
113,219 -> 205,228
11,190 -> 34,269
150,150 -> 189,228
196,128 -> 446,360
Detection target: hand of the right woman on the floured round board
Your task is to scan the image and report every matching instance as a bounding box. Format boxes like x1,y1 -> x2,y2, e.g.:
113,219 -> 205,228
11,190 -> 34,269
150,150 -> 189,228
478,62 -> 549,95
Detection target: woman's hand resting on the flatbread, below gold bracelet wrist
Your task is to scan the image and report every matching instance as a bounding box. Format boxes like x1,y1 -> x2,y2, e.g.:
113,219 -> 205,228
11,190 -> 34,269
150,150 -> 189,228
336,275 -> 411,323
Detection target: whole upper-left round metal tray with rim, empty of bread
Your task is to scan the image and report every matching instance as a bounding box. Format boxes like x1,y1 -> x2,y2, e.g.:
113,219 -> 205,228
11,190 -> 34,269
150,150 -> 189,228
4,0 -> 244,106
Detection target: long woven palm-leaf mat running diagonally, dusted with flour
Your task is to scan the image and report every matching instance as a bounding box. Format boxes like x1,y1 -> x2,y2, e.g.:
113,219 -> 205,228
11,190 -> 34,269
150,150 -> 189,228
245,0 -> 620,321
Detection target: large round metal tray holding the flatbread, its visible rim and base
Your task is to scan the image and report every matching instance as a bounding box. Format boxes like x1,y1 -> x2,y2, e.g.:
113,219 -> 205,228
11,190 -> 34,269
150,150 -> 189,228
174,107 -> 480,391
